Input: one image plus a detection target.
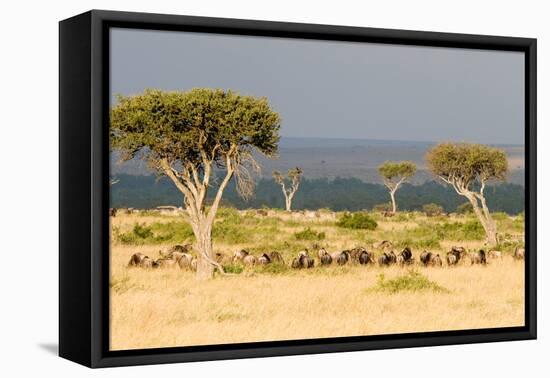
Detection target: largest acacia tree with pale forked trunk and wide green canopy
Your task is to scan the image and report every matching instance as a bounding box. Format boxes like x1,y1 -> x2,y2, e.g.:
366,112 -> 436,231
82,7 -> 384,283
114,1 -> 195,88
110,89 -> 280,279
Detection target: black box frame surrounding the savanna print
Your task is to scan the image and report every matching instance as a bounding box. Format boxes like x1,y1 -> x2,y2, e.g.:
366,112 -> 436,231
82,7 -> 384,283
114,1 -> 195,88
59,10 -> 537,368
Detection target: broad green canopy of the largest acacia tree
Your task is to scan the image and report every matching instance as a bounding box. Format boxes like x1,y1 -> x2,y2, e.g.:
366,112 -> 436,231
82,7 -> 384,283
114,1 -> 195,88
111,88 -> 280,169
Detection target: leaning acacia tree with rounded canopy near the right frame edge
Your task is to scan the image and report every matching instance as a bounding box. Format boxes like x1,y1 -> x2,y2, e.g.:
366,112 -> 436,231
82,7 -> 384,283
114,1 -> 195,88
426,143 -> 508,245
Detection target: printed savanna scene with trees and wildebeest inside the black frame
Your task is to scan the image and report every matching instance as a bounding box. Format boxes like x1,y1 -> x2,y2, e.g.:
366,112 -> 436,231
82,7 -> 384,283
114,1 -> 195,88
110,29 -> 529,350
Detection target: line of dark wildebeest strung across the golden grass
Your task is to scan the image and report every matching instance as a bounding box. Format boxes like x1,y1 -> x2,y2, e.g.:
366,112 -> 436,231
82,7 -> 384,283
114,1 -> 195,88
128,240 -> 525,270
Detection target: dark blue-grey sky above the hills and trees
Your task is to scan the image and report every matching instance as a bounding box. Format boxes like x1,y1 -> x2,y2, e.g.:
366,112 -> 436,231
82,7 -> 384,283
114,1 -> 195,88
111,29 -> 524,144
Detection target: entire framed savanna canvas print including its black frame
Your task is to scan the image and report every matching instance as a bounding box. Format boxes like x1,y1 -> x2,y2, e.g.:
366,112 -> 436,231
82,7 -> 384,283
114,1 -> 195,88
59,11 -> 536,367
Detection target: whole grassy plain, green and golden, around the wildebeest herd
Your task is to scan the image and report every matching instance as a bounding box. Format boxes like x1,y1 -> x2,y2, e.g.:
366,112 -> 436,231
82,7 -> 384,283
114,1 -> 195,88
110,208 -> 524,350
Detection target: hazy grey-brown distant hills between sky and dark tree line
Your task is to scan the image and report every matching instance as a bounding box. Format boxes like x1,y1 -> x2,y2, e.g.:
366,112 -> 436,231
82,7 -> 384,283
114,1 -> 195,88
111,137 -> 525,185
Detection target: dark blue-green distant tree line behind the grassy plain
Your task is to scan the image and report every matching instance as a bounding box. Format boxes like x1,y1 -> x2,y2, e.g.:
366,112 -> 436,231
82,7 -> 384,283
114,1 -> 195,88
111,174 -> 525,214
